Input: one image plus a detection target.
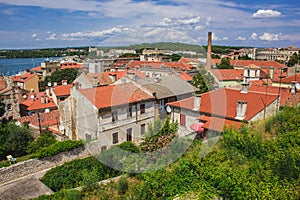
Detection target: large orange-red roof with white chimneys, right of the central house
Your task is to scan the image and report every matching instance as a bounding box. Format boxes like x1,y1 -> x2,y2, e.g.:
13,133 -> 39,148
169,88 -> 277,120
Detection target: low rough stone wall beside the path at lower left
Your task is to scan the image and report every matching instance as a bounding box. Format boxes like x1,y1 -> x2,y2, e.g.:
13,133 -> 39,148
0,147 -> 90,184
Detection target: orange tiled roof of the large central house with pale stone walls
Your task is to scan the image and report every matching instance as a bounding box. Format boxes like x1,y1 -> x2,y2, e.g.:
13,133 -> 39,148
79,83 -> 154,108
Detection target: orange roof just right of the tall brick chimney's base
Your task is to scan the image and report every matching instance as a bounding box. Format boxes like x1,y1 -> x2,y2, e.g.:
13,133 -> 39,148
210,69 -> 244,81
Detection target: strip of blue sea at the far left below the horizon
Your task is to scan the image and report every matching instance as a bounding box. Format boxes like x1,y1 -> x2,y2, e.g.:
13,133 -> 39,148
0,57 -> 59,76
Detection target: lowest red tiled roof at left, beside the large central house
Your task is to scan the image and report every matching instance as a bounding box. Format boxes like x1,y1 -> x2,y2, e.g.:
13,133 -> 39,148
18,110 -> 60,127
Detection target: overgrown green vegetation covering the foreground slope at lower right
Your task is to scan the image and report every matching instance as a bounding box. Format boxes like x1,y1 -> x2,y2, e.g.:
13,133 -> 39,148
39,107 -> 300,199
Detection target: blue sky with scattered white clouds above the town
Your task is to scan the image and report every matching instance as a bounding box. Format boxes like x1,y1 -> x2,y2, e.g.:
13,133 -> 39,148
0,0 -> 300,49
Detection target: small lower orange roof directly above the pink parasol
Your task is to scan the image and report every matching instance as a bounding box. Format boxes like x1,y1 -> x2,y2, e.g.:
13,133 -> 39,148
199,115 -> 241,132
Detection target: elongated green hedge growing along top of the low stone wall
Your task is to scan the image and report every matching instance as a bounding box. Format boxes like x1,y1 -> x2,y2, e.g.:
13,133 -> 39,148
33,140 -> 83,159
